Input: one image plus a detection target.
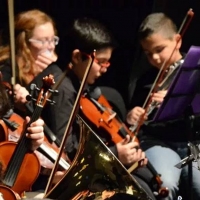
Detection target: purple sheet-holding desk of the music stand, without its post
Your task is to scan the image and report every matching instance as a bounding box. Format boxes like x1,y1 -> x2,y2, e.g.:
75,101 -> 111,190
153,46 -> 200,121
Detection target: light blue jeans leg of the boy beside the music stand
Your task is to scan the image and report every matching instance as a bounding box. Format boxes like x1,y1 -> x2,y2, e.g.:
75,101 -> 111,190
145,146 -> 181,200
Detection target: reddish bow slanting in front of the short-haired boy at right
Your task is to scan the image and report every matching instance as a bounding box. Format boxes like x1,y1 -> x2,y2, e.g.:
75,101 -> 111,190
130,8 -> 194,135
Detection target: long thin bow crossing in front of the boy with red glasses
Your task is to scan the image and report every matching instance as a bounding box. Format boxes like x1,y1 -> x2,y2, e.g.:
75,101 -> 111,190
44,50 -> 96,196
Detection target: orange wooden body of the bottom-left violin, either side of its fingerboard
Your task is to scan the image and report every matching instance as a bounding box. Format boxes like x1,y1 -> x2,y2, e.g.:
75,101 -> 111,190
0,141 -> 40,195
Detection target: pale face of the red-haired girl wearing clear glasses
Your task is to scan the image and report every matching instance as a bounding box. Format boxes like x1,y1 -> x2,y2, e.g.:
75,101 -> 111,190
29,22 -> 58,59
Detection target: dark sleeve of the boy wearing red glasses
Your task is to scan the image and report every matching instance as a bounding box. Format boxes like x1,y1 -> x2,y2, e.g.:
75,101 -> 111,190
42,79 -> 78,157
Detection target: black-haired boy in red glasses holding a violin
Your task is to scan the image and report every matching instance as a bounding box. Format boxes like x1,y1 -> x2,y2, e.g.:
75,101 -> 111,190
30,18 -> 154,199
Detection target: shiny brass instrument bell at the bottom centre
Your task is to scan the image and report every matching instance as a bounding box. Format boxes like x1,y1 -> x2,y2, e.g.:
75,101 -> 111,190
45,116 -> 151,200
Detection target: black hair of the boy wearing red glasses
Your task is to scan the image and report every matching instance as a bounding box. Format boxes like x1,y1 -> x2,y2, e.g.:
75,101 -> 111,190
59,17 -> 117,65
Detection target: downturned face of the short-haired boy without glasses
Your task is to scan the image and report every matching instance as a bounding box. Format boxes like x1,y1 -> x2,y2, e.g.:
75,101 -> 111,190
141,32 -> 181,68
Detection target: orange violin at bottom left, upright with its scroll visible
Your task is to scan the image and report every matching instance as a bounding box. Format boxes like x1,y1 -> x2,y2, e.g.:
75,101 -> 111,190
0,75 -> 54,199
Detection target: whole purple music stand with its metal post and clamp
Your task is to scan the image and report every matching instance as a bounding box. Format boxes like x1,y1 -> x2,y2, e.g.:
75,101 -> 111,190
153,46 -> 200,199
